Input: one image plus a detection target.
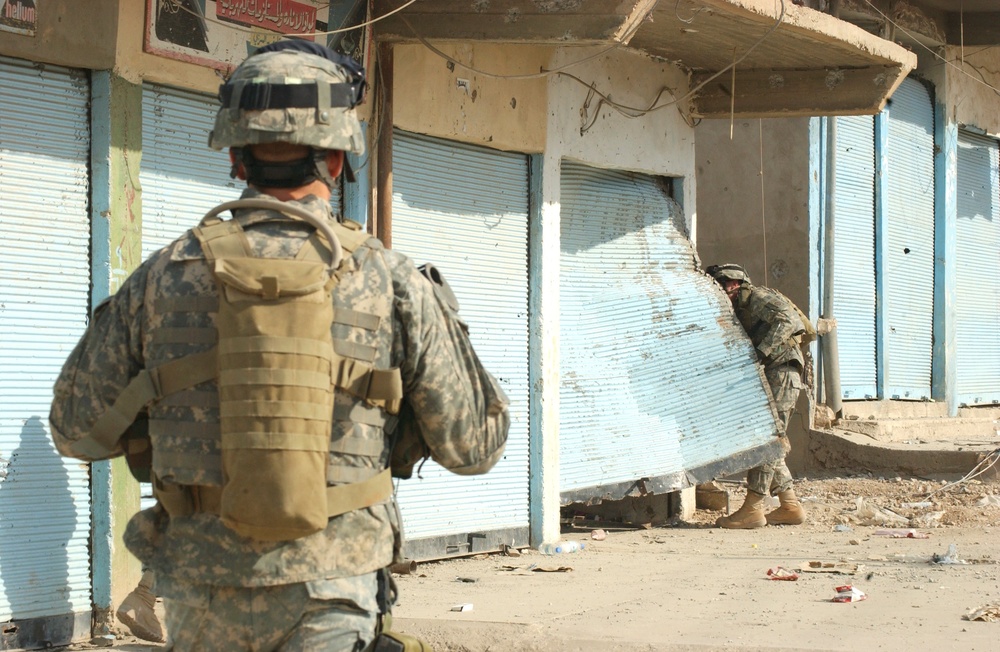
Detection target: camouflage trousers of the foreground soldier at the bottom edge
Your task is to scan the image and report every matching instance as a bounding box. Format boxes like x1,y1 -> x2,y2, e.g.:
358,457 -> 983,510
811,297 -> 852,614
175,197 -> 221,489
157,573 -> 378,652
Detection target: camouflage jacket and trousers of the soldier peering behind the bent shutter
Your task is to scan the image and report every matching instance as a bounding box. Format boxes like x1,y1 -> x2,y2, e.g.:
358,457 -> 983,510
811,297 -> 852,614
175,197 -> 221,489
733,283 -> 805,496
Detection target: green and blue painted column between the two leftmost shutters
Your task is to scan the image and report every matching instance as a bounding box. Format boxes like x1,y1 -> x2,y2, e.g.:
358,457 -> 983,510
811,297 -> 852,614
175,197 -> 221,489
90,71 -> 142,635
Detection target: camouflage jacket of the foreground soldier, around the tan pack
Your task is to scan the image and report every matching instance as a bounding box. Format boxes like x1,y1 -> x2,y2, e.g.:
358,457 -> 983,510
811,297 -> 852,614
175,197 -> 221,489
50,190 -> 509,597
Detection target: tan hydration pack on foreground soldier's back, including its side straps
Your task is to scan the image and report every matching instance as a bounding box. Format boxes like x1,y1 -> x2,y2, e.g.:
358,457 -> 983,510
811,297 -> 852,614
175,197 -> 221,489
76,199 -> 402,541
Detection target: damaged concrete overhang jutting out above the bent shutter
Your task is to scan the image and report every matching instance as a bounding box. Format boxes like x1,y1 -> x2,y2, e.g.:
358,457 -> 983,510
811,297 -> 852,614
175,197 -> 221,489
374,0 -> 917,118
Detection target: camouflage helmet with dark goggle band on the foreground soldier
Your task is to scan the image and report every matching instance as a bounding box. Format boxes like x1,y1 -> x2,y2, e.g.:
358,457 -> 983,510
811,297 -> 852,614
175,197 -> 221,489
208,39 -> 365,188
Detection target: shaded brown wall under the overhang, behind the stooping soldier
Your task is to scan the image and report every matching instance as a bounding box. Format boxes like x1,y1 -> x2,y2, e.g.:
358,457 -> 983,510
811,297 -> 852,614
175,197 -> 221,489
694,118 -> 810,310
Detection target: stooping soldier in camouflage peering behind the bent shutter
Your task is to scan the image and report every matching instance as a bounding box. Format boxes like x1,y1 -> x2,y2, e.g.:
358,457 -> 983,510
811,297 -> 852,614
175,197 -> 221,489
705,264 -> 806,529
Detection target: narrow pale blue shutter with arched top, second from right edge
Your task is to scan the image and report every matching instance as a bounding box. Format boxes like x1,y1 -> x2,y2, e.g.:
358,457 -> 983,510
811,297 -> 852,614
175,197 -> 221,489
882,79 -> 934,399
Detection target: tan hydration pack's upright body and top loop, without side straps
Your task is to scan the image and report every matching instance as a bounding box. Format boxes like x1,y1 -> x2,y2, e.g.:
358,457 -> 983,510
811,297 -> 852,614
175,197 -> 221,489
194,202 -> 343,540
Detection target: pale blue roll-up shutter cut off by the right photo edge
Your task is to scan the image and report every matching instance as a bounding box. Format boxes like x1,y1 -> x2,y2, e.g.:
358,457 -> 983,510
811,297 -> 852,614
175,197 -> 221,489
955,131 -> 1000,405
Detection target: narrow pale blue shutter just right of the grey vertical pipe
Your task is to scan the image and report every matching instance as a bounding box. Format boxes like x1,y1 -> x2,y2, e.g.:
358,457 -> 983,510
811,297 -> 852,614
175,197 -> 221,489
833,116 -> 878,399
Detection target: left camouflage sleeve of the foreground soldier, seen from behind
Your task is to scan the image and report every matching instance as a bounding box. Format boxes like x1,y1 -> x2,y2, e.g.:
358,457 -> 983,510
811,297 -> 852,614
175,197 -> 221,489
49,268 -> 145,461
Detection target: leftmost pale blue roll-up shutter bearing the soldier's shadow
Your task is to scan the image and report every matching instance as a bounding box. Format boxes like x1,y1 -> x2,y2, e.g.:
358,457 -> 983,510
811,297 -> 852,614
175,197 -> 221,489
0,57 -> 92,649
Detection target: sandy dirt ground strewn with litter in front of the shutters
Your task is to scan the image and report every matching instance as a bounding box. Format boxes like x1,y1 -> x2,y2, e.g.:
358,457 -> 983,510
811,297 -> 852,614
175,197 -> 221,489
60,476 -> 1000,652
